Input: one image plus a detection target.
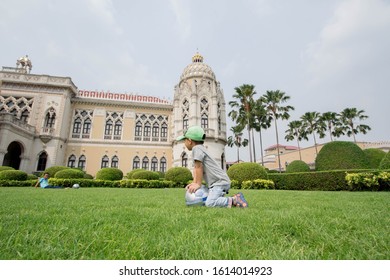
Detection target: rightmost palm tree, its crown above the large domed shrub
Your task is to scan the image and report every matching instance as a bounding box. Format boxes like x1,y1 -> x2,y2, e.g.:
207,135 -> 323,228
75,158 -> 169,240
339,108 -> 371,143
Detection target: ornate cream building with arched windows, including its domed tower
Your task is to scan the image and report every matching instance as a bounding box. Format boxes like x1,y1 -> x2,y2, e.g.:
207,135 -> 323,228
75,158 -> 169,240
0,53 -> 226,175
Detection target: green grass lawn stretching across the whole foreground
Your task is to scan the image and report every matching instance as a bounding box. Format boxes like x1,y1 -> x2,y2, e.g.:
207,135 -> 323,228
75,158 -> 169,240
0,188 -> 390,260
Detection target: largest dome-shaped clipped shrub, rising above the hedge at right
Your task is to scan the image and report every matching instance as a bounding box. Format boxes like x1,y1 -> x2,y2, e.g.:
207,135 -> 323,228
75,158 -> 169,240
315,141 -> 370,171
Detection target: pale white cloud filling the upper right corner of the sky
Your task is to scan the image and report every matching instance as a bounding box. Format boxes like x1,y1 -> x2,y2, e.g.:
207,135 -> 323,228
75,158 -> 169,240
307,0 -> 390,84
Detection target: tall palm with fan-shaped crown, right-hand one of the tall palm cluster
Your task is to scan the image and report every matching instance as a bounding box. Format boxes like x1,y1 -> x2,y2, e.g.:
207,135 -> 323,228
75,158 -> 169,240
261,90 -> 294,172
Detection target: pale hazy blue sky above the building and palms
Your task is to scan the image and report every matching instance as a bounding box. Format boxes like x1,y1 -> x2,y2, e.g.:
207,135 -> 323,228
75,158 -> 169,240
0,0 -> 390,161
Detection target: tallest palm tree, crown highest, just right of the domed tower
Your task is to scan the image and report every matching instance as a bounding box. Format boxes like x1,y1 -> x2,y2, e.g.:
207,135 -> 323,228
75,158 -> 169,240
228,84 -> 256,162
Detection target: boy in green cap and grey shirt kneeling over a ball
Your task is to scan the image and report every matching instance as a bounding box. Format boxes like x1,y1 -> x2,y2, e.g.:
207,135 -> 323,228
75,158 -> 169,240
176,126 -> 248,208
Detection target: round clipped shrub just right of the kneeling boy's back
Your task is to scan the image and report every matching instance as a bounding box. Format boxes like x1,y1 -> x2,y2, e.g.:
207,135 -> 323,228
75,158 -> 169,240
227,162 -> 268,184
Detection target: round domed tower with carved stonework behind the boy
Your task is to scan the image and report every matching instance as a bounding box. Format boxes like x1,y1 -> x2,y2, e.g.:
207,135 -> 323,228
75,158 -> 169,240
172,53 -> 226,169
